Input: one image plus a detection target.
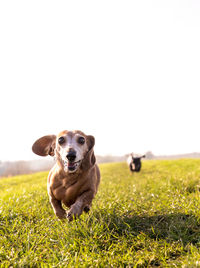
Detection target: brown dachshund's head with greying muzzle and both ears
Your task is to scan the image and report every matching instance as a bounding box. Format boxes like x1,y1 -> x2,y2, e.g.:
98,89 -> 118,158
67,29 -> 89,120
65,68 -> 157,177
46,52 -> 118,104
32,130 -> 96,173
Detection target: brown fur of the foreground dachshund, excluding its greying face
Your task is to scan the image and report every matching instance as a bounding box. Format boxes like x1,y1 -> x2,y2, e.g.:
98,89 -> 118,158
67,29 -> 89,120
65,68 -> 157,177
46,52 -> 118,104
32,130 -> 100,221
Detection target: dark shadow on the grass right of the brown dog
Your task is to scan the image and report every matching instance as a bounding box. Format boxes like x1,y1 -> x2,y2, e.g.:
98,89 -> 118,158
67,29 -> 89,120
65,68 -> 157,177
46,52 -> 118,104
92,211 -> 200,246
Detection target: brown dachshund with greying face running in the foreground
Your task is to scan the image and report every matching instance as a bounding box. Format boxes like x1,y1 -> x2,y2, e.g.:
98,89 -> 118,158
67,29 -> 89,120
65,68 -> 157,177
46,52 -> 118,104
32,130 -> 100,221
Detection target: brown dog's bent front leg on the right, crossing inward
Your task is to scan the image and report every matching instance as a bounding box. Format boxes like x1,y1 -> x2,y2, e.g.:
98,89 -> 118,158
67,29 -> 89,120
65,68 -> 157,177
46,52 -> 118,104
67,190 -> 94,221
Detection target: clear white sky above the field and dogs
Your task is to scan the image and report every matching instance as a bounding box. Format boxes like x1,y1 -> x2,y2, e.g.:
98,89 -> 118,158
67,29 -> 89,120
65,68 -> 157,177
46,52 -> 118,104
0,0 -> 200,160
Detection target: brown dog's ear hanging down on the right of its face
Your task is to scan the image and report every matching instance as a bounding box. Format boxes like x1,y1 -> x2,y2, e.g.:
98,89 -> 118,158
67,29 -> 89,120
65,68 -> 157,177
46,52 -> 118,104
82,135 -> 96,170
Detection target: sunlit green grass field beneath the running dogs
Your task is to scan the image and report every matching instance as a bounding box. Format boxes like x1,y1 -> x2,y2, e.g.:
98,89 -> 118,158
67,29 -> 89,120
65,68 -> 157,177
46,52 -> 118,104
0,160 -> 200,267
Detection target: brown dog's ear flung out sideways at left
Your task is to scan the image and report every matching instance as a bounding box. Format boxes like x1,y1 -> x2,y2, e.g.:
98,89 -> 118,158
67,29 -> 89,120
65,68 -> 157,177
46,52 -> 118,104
32,135 -> 56,156
